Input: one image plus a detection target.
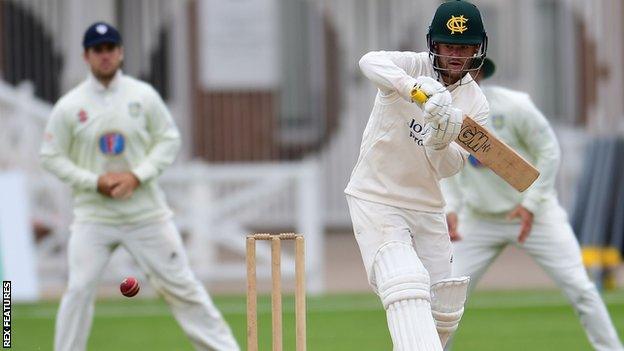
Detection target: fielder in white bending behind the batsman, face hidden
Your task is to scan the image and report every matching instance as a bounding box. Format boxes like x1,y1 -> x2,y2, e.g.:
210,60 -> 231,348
442,59 -> 624,351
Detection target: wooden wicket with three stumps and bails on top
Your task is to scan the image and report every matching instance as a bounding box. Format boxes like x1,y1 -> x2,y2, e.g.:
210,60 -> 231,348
247,233 -> 306,351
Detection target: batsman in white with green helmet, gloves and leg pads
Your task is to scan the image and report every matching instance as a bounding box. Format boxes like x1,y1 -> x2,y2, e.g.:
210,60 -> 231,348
345,1 -> 488,351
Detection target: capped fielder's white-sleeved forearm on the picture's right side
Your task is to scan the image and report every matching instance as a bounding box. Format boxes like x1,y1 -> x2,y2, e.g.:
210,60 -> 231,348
132,136 -> 181,183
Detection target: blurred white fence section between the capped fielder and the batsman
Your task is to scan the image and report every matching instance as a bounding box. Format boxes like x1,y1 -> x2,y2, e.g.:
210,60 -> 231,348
162,159 -> 325,293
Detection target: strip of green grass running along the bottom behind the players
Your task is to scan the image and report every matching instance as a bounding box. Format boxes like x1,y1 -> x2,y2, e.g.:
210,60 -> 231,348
13,291 -> 624,351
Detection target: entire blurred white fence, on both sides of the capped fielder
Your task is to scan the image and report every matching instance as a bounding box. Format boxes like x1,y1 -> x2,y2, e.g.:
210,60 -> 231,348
0,80 -> 324,293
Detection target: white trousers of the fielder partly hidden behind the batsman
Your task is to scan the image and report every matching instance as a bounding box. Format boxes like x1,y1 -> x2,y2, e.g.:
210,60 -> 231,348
453,205 -> 624,351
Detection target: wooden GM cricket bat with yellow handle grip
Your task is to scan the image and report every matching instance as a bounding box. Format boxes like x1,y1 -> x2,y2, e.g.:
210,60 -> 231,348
412,89 -> 539,192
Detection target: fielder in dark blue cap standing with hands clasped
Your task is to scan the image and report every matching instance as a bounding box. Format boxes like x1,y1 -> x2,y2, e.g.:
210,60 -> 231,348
41,22 -> 239,351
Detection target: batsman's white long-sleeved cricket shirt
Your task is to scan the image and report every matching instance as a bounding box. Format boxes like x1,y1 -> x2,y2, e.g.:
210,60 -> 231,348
345,51 -> 489,212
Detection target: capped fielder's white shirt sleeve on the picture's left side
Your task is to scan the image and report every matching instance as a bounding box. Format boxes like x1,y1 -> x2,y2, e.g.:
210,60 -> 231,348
39,105 -> 98,191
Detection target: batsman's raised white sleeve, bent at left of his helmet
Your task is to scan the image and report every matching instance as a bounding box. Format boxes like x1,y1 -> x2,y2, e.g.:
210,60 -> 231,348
359,51 -> 417,101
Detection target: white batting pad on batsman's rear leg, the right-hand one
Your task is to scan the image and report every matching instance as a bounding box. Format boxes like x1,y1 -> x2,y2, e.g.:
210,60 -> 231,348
431,277 -> 470,347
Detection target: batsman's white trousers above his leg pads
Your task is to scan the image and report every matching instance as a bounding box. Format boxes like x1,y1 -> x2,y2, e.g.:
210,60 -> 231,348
347,196 -> 451,289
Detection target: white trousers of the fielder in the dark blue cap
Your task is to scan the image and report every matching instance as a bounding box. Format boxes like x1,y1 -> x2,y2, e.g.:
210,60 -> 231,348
54,221 -> 239,351
